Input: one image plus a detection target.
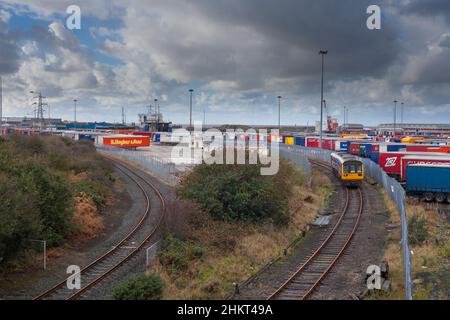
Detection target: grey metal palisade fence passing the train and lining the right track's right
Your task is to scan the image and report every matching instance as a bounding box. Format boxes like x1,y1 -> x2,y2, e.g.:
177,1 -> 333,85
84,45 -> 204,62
280,145 -> 412,300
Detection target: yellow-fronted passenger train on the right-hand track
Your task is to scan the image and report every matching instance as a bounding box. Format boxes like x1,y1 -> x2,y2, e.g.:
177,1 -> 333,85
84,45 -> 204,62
331,153 -> 364,187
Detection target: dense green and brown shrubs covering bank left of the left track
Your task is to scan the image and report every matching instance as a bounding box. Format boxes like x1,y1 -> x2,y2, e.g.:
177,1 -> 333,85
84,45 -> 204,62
0,136 -> 112,263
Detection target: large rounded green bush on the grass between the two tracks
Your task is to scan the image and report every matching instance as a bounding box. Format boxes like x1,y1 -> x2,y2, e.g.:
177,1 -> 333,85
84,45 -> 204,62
178,160 -> 304,224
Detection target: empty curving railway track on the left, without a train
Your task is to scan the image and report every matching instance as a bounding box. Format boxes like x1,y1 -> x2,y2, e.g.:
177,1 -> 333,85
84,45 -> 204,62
33,159 -> 166,300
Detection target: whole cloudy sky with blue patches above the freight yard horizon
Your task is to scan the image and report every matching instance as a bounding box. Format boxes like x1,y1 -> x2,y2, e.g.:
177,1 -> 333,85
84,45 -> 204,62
0,0 -> 450,125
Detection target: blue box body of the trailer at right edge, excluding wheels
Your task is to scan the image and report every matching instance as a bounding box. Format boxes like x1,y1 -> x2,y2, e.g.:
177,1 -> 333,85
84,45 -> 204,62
406,165 -> 450,193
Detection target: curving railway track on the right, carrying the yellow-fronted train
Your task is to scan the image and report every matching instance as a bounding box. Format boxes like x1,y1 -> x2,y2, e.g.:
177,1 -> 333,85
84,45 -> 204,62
267,161 -> 364,300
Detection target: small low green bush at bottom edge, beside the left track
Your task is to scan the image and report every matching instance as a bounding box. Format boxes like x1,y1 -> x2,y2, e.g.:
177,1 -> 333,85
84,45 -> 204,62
113,274 -> 164,300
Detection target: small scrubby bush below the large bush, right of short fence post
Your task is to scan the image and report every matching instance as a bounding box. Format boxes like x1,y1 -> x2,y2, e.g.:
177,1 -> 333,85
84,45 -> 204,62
158,234 -> 206,276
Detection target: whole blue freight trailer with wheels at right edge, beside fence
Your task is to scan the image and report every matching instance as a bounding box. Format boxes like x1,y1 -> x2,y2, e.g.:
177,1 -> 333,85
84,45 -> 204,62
406,164 -> 450,203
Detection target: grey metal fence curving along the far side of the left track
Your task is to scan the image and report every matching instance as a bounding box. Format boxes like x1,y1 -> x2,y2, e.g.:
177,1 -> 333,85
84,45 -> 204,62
96,145 -> 178,186
